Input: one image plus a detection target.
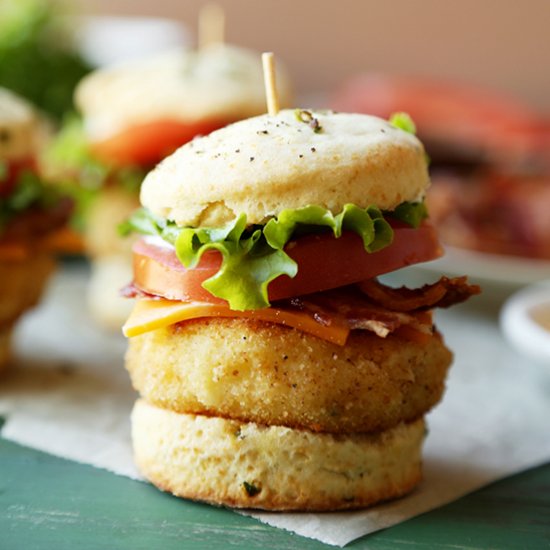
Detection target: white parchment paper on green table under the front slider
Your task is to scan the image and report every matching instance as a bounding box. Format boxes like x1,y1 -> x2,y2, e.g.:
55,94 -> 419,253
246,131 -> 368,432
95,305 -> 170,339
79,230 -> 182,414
0,265 -> 550,546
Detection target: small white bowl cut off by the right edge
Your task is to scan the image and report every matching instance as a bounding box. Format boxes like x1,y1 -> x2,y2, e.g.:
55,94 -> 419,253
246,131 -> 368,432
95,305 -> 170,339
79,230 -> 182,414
500,281 -> 550,366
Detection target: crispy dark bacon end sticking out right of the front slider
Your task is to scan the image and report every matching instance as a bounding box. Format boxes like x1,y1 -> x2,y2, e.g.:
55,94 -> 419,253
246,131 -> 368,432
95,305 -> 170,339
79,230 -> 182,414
357,277 -> 481,311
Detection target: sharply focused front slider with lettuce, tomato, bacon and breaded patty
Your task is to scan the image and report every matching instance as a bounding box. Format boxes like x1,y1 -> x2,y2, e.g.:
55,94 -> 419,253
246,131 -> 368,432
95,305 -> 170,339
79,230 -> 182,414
123,110 -> 479,510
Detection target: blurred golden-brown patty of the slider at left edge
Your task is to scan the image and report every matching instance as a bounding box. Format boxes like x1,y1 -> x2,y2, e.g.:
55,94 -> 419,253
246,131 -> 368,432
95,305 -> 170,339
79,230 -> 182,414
0,252 -> 55,369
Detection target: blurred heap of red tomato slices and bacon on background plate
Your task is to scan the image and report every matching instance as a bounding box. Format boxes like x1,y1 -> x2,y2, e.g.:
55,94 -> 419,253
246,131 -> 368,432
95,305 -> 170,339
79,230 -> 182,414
332,74 -> 550,268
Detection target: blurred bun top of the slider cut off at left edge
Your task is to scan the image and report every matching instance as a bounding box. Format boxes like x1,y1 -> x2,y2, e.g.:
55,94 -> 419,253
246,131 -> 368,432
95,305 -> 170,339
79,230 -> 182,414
0,88 -> 41,160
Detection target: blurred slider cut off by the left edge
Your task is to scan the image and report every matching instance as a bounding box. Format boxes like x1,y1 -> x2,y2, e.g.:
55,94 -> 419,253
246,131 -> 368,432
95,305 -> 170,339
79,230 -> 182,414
0,88 -> 71,370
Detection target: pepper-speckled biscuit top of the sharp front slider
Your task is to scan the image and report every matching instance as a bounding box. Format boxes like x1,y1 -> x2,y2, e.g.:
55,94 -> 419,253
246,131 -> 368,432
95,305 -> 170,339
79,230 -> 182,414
141,110 -> 429,226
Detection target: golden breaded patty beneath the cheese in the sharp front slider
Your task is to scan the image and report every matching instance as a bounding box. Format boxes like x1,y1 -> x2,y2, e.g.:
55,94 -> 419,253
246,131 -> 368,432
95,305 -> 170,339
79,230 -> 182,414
126,319 -> 451,433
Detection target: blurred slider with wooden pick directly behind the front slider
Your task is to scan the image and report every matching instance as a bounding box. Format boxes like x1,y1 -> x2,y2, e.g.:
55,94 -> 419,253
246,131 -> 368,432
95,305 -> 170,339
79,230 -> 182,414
44,6 -> 290,330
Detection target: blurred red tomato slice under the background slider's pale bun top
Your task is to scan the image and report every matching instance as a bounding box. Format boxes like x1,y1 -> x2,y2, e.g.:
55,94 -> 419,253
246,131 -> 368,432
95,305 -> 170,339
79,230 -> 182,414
91,120 -> 235,167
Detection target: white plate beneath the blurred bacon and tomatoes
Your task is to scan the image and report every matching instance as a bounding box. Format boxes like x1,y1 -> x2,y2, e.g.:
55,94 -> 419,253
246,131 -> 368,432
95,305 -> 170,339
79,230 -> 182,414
418,246 -> 550,286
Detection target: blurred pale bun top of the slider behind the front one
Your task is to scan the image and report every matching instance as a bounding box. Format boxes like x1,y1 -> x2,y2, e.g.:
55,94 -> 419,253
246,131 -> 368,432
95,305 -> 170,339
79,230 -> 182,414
75,44 -> 296,141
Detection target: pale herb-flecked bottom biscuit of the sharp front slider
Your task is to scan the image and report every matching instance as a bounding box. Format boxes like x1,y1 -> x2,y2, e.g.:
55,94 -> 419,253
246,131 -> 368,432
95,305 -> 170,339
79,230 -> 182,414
132,400 -> 425,511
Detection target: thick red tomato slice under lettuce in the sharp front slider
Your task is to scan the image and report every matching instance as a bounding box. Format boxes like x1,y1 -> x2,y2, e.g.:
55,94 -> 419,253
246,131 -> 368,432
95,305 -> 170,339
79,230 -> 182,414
134,223 -> 442,303
